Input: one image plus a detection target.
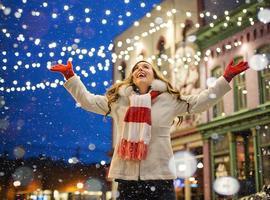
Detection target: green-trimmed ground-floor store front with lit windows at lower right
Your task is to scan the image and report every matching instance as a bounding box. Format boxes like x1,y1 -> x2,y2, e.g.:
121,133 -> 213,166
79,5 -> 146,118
199,104 -> 270,199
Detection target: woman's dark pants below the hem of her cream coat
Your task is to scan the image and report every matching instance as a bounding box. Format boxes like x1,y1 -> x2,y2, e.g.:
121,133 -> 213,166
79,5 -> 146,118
116,179 -> 176,200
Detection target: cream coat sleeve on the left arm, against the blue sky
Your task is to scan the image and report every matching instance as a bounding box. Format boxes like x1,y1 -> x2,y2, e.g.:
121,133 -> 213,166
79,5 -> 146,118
64,75 -> 109,115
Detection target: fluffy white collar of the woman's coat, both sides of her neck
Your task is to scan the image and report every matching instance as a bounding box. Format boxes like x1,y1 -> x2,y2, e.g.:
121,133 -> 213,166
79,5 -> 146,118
118,79 -> 167,96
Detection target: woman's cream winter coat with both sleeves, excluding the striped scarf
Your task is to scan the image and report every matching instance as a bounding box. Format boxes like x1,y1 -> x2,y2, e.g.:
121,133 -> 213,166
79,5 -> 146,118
64,76 -> 231,180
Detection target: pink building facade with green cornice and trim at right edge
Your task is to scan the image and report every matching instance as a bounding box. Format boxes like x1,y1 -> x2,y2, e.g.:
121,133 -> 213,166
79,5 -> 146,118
194,2 -> 270,199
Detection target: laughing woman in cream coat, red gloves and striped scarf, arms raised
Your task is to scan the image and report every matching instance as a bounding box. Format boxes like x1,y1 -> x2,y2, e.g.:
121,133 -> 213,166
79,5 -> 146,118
51,58 -> 248,200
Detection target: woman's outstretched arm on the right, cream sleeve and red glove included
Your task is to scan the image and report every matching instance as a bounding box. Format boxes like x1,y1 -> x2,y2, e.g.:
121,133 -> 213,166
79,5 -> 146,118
176,61 -> 248,115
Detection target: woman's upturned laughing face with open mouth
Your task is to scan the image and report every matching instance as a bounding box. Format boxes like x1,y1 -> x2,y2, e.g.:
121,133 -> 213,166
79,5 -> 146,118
132,62 -> 154,87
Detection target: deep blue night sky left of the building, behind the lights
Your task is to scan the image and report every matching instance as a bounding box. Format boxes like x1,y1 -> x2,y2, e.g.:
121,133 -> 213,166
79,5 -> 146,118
0,0 -> 160,163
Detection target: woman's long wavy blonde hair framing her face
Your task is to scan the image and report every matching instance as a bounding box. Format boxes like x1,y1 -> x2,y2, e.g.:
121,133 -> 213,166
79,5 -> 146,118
105,60 -> 189,122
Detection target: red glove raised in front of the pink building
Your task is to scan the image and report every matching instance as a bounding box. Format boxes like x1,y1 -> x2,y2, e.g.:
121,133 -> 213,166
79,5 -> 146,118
223,60 -> 249,82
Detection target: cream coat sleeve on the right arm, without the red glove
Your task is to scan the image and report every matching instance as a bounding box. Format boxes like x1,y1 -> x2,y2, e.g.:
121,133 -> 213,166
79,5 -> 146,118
176,76 -> 231,115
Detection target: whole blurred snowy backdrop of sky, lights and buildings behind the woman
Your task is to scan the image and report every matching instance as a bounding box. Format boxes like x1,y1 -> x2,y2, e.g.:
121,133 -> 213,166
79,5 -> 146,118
0,0 -> 270,200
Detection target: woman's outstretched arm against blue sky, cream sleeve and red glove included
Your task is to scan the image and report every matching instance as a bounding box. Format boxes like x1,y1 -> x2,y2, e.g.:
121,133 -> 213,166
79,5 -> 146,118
50,61 -> 109,115
